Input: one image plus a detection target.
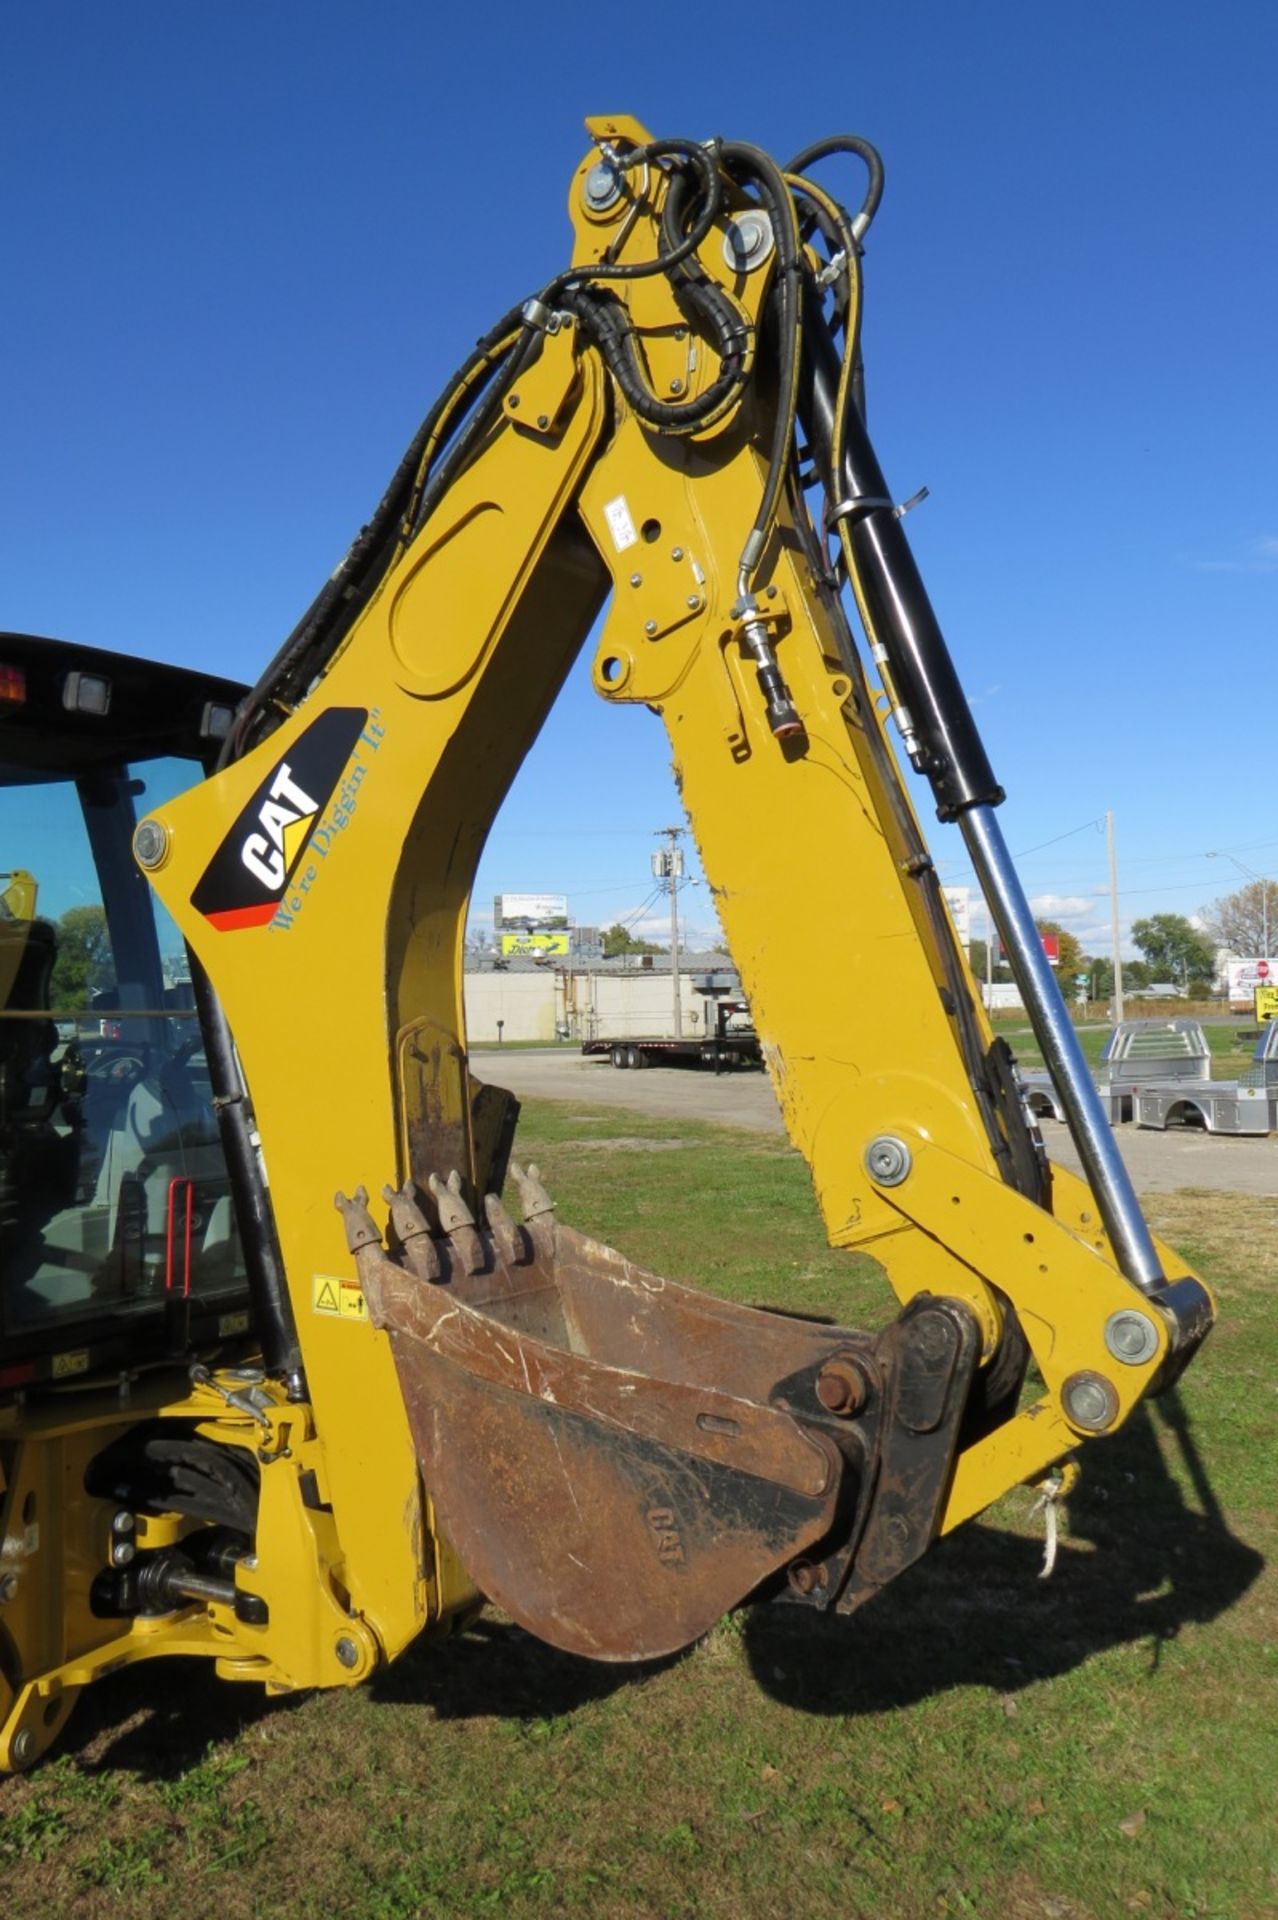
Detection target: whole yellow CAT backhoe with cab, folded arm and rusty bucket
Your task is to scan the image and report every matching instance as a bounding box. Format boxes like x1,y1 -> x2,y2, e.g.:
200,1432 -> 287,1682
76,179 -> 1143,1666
0,117 -> 1213,1768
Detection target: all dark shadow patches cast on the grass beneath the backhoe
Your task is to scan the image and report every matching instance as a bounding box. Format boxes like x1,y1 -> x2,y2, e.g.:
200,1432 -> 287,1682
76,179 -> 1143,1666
49,1392 -> 1265,1780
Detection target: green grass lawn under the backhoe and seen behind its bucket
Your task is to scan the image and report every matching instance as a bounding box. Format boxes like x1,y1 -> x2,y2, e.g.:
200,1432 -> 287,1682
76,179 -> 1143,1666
0,1102 -> 1278,1920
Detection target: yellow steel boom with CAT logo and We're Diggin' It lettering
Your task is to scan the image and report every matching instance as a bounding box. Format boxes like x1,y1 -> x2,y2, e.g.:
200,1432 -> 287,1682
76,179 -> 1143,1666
142,336 -> 604,1655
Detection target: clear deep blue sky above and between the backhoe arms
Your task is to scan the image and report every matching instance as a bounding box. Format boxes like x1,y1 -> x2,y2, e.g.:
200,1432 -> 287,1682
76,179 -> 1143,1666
0,0 -> 1278,952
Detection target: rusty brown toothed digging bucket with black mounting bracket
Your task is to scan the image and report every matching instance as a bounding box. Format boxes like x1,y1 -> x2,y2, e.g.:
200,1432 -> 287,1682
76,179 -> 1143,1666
338,1165 -> 977,1661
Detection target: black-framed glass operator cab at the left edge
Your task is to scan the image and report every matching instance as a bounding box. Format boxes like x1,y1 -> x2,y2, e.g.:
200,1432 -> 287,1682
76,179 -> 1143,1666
0,636 -> 249,1398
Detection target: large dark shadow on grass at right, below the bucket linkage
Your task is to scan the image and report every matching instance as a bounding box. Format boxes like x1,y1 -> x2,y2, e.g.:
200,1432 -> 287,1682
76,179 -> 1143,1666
745,1392 -> 1265,1715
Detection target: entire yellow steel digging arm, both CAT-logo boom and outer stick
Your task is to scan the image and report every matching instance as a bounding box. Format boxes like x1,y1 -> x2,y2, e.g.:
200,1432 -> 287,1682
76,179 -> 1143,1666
129,121 -> 1205,1682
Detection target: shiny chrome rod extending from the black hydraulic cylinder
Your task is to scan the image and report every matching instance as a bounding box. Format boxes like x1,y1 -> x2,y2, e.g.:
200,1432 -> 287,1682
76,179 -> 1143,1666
959,806 -> 1165,1292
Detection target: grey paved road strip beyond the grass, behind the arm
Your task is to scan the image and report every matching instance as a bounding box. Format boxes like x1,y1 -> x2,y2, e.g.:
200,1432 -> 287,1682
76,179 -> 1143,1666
474,1046 -> 1278,1194
